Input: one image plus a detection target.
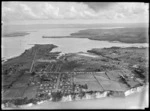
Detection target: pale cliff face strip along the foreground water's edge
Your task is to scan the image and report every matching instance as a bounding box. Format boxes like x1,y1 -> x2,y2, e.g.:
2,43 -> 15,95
1,83 -> 149,109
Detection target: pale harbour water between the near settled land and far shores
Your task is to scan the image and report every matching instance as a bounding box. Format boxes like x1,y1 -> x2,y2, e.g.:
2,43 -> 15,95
1,27 -> 148,59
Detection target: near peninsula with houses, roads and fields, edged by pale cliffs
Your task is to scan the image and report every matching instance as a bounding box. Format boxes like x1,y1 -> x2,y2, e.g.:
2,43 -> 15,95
2,44 -> 148,107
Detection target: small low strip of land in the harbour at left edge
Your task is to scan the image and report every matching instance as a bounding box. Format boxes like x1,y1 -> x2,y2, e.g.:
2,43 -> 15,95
3,32 -> 30,37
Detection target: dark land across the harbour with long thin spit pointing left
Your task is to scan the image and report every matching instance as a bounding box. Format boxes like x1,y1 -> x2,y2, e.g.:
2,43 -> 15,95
43,27 -> 148,43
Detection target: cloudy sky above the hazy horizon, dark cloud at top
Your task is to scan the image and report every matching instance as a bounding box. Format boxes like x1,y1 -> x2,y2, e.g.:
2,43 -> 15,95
2,2 -> 149,24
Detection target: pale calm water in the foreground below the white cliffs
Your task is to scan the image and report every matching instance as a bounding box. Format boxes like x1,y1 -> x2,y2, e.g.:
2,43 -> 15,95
18,86 -> 149,109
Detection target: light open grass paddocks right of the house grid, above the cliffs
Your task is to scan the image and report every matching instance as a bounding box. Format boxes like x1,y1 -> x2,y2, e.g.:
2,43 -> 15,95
74,72 -> 131,91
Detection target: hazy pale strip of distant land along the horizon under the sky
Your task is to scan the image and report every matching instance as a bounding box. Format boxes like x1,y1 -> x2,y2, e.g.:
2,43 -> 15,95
2,23 -> 148,32
